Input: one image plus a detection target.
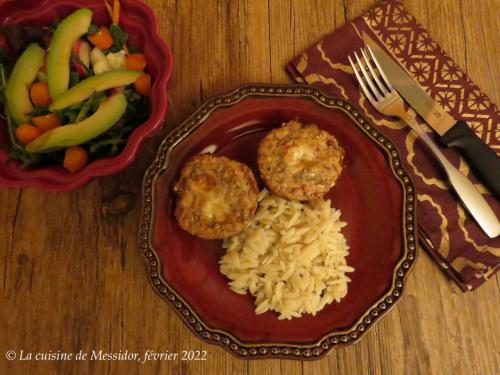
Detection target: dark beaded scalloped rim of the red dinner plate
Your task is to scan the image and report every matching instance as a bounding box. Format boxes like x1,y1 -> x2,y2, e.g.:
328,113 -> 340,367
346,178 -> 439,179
139,84 -> 417,360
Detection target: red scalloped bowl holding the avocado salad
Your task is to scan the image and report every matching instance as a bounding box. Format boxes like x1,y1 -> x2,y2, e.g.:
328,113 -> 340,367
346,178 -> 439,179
0,0 -> 173,192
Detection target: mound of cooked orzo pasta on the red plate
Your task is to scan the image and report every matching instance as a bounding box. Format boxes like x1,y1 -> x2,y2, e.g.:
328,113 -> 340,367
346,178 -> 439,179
219,189 -> 354,319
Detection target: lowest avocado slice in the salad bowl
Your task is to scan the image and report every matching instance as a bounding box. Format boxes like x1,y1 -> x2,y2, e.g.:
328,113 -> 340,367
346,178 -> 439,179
26,93 -> 127,153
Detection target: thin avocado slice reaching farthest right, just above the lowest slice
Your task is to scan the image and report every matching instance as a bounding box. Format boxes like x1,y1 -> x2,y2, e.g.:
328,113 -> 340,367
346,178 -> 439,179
49,70 -> 142,111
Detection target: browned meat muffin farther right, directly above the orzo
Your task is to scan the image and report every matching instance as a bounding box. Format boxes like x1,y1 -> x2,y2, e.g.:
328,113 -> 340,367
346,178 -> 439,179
258,121 -> 345,201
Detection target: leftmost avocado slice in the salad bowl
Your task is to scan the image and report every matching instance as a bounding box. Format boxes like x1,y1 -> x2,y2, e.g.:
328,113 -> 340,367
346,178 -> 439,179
5,43 -> 45,125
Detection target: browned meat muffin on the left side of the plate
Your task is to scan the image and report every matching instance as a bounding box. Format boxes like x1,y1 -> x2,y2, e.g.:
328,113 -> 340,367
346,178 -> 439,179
174,155 -> 259,239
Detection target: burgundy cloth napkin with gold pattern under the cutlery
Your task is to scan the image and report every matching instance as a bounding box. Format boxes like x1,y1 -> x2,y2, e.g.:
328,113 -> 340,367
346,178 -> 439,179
287,0 -> 500,291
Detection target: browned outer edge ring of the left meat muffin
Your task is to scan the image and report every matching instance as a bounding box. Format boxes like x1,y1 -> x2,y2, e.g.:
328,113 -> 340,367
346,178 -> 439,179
174,154 -> 259,240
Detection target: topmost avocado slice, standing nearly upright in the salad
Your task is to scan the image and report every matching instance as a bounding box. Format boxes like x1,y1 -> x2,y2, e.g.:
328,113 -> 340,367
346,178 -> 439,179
47,8 -> 92,100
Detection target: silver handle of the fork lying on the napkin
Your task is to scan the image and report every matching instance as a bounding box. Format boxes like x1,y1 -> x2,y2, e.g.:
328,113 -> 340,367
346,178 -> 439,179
404,118 -> 500,238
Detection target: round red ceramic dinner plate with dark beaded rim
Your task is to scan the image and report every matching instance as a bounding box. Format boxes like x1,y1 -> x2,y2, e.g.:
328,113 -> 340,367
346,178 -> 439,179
140,85 -> 416,359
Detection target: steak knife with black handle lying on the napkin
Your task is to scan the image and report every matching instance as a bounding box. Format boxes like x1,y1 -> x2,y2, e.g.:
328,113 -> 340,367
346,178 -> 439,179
362,31 -> 500,198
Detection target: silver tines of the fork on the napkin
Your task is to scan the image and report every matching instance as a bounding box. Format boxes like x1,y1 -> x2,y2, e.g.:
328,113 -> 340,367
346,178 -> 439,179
348,46 -> 394,104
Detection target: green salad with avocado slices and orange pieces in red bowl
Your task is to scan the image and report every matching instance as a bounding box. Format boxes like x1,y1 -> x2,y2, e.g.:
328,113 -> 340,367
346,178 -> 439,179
0,0 -> 151,172
